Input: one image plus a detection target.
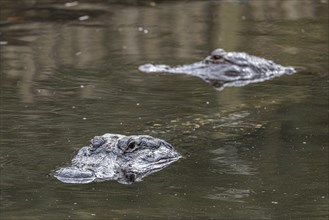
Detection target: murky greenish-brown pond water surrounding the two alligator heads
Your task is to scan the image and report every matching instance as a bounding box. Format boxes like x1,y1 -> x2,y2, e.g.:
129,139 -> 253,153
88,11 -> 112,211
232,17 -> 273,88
0,0 -> 329,219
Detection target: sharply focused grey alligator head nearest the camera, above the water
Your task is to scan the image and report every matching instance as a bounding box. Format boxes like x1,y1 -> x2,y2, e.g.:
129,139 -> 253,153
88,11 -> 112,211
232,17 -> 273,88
54,134 -> 181,184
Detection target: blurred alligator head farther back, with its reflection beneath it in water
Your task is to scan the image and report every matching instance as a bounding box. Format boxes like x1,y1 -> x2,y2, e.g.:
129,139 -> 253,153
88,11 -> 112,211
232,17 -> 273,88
138,49 -> 296,90
